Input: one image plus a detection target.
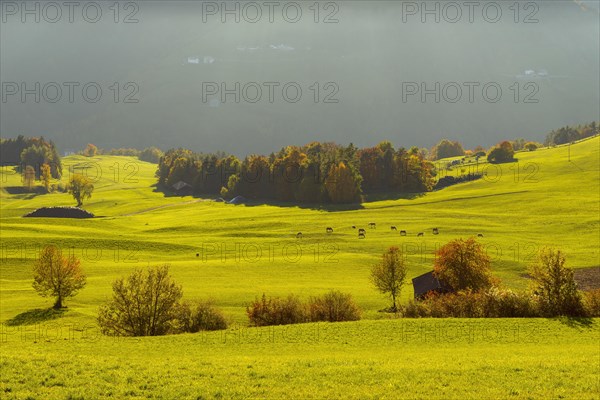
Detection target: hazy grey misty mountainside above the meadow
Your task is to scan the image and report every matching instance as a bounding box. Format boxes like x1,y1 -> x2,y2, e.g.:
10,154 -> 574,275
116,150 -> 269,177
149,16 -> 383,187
0,1 -> 600,155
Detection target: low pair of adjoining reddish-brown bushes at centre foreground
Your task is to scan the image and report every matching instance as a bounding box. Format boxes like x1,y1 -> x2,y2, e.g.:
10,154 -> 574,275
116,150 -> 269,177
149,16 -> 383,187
246,290 -> 361,326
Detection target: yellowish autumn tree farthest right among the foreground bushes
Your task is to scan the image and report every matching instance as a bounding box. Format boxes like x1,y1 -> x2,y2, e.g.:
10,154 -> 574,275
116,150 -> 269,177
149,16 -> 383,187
529,248 -> 584,317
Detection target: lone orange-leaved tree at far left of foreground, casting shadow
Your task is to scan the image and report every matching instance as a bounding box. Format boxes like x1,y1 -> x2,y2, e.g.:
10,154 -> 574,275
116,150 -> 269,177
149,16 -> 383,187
33,246 -> 86,309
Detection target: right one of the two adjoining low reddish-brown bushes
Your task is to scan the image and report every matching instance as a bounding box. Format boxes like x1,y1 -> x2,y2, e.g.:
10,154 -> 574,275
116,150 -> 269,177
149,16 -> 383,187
308,290 -> 360,322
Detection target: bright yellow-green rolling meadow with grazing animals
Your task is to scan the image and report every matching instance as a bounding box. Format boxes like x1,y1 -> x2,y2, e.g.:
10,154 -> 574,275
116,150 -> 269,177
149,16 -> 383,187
0,137 -> 600,399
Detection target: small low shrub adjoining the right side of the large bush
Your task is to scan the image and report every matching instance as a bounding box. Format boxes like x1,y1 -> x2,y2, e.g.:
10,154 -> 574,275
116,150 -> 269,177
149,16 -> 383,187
177,301 -> 227,333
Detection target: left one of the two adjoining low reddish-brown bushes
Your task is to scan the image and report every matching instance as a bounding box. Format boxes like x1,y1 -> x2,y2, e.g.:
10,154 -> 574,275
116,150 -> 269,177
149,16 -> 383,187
246,293 -> 309,326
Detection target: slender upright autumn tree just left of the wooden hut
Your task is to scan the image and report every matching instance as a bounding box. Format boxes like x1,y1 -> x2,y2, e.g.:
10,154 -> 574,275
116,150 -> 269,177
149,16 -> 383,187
371,247 -> 407,312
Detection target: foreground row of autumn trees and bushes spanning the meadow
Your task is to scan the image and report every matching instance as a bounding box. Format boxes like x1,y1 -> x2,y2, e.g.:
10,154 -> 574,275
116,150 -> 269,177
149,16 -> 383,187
33,238 -> 600,336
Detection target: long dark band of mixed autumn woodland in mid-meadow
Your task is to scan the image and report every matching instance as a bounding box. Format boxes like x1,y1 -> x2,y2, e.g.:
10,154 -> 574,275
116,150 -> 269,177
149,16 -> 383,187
157,142 -> 434,203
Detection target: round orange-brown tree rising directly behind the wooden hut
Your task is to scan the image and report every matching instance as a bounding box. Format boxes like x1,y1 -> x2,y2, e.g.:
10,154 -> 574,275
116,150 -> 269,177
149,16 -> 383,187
433,238 -> 495,292
